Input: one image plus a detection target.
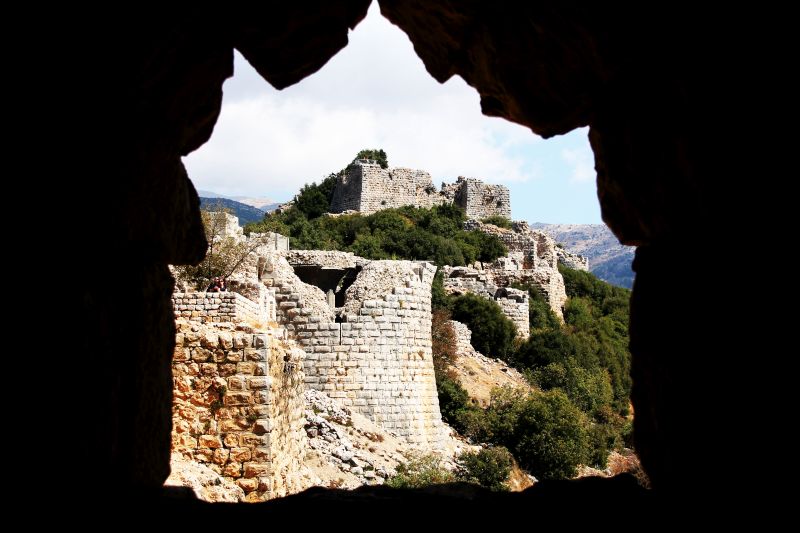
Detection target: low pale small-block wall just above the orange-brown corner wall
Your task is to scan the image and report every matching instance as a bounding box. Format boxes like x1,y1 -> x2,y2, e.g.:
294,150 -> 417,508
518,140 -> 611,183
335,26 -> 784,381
172,292 -> 275,322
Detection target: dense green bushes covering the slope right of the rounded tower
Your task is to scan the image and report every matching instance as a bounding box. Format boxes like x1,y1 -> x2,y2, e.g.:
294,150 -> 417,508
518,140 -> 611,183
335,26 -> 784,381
433,268 -> 631,479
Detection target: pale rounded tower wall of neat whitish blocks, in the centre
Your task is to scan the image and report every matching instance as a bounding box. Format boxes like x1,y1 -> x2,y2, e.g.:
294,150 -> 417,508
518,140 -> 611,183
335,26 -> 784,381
296,261 -> 443,449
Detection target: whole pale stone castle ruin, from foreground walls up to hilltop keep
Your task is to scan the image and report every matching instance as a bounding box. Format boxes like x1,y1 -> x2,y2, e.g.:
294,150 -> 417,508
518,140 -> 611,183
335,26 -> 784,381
173,169 -> 577,501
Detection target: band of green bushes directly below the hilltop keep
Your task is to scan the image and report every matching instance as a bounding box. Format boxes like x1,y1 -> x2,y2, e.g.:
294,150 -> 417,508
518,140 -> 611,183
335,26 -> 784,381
245,201 -> 507,266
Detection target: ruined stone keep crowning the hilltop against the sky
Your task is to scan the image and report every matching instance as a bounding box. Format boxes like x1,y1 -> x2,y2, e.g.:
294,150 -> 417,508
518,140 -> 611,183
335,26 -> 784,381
331,159 -> 511,219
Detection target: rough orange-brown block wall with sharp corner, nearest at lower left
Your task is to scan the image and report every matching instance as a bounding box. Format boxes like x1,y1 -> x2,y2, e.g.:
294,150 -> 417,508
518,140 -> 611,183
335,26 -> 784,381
172,320 -> 306,501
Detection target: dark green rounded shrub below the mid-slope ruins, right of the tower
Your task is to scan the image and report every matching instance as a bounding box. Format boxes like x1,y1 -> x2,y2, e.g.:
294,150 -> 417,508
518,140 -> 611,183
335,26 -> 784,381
452,294 -> 517,360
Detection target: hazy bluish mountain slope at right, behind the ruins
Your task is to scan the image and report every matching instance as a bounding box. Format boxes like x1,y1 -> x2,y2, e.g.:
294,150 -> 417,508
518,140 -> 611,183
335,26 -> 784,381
530,222 -> 636,288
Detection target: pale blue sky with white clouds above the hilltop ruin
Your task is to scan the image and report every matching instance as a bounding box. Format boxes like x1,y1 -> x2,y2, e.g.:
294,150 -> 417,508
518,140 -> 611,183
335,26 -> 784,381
184,2 -> 601,224
